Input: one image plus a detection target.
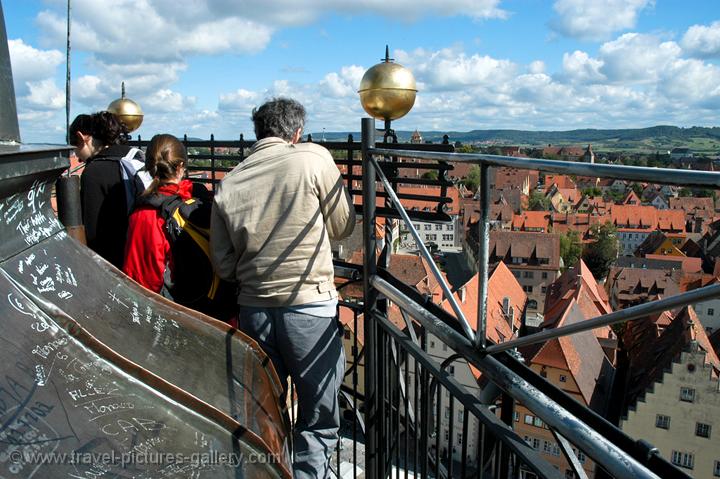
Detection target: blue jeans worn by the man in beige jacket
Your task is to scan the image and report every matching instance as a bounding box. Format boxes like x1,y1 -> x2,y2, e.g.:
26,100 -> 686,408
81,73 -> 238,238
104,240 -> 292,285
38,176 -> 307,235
238,306 -> 345,479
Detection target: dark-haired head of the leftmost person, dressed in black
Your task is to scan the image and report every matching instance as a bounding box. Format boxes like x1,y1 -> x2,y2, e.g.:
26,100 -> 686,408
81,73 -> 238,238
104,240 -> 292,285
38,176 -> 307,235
69,111 -> 127,161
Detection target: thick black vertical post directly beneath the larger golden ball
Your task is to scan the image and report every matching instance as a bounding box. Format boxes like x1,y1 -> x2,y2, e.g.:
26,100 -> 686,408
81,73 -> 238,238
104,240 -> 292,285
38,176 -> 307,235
362,118 -> 383,477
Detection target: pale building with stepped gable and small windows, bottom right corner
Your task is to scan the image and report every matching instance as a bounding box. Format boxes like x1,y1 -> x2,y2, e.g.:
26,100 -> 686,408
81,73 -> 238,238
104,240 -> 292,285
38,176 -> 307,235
620,306 -> 720,479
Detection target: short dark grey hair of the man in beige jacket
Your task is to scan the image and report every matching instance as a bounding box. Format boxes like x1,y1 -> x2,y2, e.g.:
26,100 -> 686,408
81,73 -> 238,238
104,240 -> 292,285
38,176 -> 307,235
253,98 -> 305,141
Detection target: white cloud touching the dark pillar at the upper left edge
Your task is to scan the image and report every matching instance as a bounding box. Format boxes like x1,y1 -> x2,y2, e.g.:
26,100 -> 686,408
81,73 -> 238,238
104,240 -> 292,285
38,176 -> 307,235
8,39 -> 65,94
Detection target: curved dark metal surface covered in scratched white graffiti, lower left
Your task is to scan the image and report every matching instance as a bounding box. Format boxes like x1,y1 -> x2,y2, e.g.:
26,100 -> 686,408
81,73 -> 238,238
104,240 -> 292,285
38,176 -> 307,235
0,151 -> 290,478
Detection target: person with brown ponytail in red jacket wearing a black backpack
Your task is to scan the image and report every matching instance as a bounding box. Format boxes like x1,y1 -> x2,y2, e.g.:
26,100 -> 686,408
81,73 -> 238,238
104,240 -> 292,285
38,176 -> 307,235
123,134 -> 235,319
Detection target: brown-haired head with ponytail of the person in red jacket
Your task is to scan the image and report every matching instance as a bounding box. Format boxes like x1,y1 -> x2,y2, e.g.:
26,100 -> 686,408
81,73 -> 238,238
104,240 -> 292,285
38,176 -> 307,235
144,134 -> 187,195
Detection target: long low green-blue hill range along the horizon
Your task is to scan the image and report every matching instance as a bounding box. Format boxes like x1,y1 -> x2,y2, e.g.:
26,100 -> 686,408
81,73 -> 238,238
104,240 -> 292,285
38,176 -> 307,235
313,125 -> 720,152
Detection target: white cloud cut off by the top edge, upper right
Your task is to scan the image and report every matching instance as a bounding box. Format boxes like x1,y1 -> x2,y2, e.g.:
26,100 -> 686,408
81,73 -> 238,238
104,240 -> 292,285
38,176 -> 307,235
550,0 -> 654,40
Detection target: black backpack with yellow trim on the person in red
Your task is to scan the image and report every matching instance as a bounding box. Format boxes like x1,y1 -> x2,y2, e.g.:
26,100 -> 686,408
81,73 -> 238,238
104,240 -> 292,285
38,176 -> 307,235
144,195 -> 237,321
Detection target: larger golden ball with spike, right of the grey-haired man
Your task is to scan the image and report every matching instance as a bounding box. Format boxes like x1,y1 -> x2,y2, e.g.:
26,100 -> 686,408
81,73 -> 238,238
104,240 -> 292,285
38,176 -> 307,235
358,46 -> 417,121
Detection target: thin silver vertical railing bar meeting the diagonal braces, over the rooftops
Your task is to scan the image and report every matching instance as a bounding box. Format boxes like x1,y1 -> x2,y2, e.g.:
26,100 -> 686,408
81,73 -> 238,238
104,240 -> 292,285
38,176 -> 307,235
475,165 -> 490,349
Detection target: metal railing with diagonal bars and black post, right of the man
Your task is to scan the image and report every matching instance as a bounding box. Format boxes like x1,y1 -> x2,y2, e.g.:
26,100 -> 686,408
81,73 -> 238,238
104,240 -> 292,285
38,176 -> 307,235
362,119 -> 720,477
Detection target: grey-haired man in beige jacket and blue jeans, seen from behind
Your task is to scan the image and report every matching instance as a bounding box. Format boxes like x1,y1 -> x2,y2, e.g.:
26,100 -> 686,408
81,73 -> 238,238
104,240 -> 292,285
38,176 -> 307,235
210,98 -> 355,478
